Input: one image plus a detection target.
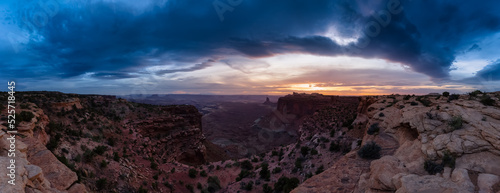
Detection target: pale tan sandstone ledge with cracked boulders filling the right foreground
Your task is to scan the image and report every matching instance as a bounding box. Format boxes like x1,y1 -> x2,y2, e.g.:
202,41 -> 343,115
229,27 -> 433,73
294,93 -> 500,193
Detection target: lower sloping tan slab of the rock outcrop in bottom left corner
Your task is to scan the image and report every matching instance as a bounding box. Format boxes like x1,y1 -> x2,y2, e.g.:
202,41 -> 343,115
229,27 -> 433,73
0,131 -> 87,193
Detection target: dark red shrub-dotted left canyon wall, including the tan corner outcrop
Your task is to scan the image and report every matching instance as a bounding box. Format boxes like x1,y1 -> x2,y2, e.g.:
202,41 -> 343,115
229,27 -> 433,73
0,92 -> 220,193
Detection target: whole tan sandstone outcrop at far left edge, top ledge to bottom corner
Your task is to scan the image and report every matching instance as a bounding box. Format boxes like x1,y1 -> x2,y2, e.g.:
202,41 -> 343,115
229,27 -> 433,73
0,103 -> 87,193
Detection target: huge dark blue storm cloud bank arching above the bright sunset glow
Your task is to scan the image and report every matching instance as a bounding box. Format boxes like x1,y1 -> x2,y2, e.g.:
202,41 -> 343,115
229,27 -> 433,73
1,0 -> 500,80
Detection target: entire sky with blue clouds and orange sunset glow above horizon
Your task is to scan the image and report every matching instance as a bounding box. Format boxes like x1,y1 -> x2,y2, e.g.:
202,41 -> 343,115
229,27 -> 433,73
0,0 -> 500,95
